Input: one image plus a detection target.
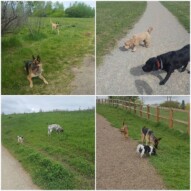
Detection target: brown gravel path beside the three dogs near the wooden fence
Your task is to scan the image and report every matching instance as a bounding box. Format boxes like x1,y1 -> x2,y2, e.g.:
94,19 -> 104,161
96,115 -> 165,190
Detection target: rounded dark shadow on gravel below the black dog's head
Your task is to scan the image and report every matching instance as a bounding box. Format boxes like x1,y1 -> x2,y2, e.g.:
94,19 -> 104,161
135,80 -> 153,95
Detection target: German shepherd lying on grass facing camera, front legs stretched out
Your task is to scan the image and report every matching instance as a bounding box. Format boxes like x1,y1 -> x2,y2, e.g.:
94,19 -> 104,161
25,56 -> 48,88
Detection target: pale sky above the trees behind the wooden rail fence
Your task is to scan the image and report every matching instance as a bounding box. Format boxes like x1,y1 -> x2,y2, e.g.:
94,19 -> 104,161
97,96 -> 190,104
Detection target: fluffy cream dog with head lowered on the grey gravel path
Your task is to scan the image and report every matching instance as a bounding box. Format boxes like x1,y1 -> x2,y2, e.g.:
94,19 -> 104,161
124,27 -> 153,52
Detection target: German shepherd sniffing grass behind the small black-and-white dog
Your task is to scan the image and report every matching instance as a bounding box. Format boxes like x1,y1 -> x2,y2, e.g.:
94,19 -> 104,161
141,127 -> 162,149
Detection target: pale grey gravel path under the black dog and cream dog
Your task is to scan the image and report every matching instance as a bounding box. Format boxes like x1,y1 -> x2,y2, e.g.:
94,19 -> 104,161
97,1 -> 190,95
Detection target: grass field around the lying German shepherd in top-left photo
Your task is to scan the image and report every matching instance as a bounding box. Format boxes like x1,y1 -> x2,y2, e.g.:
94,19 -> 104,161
1,18 -> 95,95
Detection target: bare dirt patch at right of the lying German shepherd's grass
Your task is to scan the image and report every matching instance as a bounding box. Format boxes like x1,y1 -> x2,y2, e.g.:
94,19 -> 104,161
70,56 -> 95,95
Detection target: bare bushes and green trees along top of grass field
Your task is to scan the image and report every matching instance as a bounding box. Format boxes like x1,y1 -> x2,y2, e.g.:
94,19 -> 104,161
1,1 -> 95,35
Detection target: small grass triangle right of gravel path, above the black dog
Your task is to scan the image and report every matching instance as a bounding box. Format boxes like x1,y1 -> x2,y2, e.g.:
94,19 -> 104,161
161,1 -> 190,33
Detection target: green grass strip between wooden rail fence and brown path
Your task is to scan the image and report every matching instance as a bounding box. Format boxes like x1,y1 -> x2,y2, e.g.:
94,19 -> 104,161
97,104 -> 190,190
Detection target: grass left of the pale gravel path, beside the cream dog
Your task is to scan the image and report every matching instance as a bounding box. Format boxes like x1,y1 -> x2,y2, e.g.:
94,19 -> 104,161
96,1 -> 147,64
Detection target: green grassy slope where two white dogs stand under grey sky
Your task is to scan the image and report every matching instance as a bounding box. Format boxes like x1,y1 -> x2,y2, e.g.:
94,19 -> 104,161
2,110 -> 95,190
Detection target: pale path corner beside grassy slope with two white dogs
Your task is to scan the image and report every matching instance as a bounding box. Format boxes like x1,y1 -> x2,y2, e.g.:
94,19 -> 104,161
1,147 -> 39,190
